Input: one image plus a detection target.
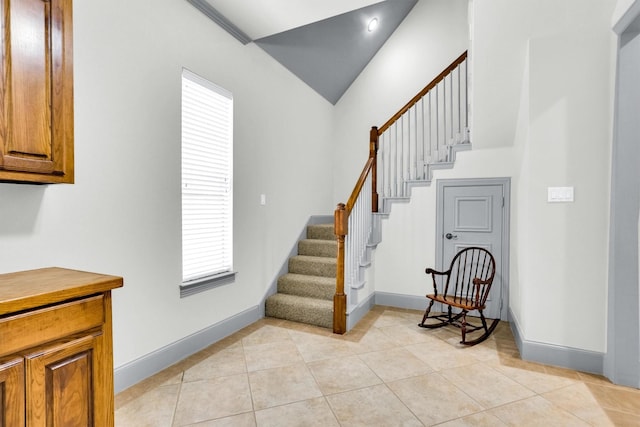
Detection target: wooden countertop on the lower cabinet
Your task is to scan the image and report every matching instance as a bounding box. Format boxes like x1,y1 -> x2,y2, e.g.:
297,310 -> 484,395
0,267 -> 123,316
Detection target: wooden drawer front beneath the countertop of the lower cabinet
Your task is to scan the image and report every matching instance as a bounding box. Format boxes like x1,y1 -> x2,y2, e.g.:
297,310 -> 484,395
0,295 -> 104,357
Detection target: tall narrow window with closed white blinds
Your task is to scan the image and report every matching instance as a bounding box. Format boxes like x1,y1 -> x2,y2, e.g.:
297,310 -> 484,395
180,70 -> 234,296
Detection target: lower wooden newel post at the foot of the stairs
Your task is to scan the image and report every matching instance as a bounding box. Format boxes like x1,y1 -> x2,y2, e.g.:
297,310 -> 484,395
333,203 -> 349,334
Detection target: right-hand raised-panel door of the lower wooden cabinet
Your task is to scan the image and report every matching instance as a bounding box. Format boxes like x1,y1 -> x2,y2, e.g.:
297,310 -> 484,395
25,332 -> 102,427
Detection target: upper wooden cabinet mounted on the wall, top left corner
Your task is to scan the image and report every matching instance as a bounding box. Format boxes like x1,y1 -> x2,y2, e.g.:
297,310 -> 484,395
0,0 -> 74,183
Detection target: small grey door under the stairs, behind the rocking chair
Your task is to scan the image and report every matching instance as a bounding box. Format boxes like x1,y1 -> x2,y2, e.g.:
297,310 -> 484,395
437,180 -> 507,318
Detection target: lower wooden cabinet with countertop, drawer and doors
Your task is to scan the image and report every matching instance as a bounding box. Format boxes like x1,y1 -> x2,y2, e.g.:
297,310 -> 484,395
0,268 -> 122,427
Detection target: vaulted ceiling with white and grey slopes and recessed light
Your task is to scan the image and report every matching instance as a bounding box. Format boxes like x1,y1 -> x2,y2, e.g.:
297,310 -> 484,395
187,0 -> 417,104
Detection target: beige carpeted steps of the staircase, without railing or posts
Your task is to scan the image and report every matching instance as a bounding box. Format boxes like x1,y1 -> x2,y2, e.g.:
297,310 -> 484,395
265,223 -> 337,328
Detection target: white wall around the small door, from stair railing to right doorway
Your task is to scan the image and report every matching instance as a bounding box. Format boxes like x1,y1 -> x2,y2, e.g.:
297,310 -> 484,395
375,0 -> 615,352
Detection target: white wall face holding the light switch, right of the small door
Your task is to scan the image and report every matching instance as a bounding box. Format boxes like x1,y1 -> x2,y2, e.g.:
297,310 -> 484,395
516,25 -> 614,352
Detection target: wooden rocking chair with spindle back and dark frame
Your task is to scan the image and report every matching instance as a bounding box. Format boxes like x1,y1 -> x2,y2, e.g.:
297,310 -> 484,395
418,247 -> 500,345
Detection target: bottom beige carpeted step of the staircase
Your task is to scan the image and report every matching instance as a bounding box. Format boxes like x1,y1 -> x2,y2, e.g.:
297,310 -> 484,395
265,293 -> 333,328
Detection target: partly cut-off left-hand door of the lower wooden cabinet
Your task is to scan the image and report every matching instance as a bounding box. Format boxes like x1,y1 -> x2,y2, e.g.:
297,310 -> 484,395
0,357 -> 24,427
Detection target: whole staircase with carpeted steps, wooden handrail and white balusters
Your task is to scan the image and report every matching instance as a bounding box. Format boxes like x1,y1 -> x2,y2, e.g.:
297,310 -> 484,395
265,52 -> 471,334
